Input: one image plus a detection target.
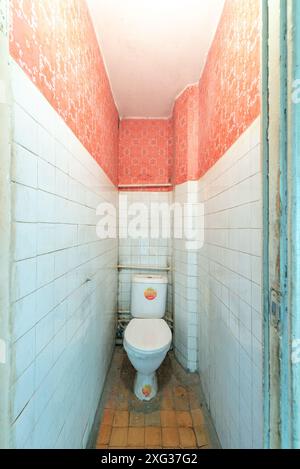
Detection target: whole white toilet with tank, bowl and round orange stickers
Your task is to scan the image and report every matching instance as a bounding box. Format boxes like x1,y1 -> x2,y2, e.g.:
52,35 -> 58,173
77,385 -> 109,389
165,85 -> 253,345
123,274 -> 172,401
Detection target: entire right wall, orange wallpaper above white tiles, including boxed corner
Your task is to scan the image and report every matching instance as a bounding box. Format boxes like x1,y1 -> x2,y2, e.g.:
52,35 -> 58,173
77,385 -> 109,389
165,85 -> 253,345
169,0 -> 263,447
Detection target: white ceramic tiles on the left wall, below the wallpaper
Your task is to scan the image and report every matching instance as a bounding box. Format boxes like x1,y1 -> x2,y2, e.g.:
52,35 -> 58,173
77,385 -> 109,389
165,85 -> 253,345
11,64 -> 118,448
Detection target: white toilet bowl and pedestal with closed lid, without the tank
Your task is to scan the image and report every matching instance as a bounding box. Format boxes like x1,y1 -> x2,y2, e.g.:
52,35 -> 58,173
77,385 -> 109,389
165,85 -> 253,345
124,319 -> 172,401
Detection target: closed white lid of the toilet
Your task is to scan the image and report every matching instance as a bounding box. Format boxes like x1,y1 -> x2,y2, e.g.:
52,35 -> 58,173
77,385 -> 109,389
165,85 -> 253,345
124,319 -> 172,351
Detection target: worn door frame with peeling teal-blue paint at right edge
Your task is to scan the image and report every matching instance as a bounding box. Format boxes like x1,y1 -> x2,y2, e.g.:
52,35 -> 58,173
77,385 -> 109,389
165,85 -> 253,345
262,0 -> 300,448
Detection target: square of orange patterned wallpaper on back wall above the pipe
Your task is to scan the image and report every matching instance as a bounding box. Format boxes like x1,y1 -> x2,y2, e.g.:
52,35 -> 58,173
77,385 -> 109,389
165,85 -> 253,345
119,119 -> 173,191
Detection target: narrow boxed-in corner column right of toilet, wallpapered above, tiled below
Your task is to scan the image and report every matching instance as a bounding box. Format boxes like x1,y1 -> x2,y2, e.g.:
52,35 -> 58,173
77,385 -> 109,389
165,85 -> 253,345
172,85 -> 199,371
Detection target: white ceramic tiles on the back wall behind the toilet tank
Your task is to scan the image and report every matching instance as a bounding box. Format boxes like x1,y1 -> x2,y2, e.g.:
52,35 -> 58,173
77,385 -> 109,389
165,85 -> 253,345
118,192 -> 173,313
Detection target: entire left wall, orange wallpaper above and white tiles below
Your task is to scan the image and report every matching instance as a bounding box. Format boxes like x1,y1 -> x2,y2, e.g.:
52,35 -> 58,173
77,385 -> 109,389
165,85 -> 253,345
10,0 -> 118,448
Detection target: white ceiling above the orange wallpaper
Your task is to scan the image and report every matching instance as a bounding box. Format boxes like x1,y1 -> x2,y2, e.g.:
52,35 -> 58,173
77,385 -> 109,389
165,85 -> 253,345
87,0 -> 224,118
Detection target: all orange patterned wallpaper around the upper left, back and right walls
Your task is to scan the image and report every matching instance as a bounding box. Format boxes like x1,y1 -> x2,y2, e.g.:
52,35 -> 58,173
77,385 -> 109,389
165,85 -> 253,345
10,0 -> 260,190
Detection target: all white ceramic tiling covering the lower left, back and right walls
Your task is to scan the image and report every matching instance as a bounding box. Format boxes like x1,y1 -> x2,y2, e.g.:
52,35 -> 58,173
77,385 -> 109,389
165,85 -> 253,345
5,60 -> 262,448
